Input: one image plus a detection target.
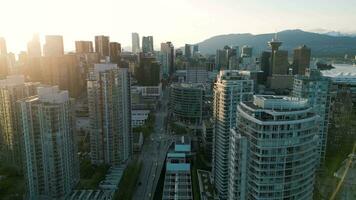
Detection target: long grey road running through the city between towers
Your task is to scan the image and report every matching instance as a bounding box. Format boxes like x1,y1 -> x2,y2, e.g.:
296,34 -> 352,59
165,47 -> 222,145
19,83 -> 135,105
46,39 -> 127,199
133,88 -> 174,200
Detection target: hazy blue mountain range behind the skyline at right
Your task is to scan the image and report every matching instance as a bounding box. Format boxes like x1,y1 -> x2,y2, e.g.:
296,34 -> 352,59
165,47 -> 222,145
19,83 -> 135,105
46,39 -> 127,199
198,29 -> 356,56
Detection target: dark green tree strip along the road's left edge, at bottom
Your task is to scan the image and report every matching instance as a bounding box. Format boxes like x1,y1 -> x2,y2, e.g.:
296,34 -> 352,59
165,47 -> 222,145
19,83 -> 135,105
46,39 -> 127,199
113,159 -> 142,200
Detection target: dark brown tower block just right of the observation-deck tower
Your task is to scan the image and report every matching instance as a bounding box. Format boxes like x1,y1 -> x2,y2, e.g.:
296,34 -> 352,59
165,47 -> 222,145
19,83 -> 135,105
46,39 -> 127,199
293,45 -> 311,75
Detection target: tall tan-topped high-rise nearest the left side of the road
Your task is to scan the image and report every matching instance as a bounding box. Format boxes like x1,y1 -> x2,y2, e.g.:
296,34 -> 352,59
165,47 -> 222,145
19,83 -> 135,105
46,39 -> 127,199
87,63 -> 133,166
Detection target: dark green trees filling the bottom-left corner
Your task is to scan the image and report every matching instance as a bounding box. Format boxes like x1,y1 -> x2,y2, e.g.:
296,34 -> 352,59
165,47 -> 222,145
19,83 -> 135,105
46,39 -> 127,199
0,167 -> 25,200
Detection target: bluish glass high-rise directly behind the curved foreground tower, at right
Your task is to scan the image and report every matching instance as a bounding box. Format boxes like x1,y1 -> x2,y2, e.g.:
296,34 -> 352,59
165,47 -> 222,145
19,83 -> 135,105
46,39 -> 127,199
292,69 -> 332,164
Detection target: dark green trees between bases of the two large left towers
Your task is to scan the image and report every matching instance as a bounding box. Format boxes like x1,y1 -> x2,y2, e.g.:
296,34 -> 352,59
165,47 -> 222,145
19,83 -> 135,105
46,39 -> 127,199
77,159 -> 109,190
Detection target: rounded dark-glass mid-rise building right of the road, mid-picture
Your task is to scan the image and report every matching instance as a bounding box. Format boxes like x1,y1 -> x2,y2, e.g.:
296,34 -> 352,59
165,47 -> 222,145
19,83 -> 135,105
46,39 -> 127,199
170,83 -> 204,126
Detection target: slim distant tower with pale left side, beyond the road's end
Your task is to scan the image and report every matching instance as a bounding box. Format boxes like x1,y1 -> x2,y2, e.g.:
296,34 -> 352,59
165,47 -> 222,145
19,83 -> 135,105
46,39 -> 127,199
161,42 -> 174,77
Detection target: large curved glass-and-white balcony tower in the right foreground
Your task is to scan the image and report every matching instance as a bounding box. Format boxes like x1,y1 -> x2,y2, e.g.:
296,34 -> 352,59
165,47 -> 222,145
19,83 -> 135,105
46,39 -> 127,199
228,96 -> 318,199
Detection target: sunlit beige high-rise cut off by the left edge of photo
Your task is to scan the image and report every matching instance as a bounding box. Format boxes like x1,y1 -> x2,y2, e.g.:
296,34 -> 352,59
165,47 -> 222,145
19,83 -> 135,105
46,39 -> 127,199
0,75 -> 39,168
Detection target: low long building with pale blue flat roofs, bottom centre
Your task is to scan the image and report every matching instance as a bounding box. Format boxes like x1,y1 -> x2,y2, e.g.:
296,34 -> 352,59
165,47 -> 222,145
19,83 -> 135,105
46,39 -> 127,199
162,137 -> 193,200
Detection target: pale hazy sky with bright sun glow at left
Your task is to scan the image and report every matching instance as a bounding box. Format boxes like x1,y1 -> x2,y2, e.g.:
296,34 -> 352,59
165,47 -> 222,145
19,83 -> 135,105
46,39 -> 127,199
0,0 -> 356,52
